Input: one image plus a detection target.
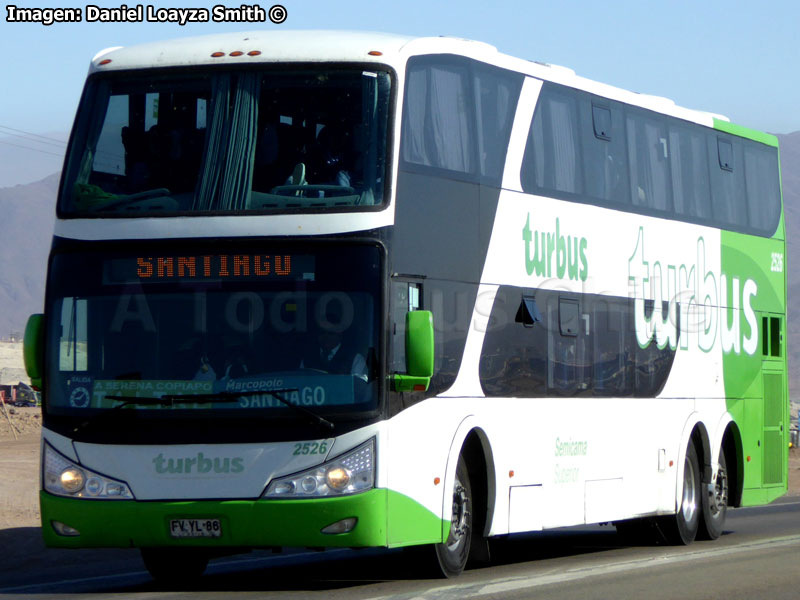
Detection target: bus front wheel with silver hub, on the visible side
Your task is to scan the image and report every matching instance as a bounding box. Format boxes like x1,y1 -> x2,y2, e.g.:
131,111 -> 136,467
434,456 -> 472,577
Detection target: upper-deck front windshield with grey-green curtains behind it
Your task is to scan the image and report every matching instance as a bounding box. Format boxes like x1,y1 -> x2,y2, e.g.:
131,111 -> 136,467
60,67 -> 390,217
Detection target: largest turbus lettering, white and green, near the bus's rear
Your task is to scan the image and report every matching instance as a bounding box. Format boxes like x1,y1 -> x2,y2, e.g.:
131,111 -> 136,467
628,227 -> 758,354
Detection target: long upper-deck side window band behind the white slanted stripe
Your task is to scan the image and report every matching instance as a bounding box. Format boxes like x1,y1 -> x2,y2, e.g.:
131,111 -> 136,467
520,82 -> 781,236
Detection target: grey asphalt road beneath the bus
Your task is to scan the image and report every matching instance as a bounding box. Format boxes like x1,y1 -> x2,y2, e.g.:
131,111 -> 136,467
0,498 -> 800,600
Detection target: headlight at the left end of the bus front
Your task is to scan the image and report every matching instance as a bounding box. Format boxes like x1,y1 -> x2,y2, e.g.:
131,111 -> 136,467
43,443 -> 133,500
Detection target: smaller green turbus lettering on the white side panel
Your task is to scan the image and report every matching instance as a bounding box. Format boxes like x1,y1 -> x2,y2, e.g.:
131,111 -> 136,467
522,213 -> 589,281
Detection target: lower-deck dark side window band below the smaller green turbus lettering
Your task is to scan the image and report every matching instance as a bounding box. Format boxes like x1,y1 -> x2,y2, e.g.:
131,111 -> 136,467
480,286 -> 680,398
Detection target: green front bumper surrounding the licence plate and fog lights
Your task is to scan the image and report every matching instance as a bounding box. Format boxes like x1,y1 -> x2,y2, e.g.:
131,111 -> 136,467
39,489 -> 387,548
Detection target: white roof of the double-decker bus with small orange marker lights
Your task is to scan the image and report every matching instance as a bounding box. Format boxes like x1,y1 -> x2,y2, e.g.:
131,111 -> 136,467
90,29 -> 728,127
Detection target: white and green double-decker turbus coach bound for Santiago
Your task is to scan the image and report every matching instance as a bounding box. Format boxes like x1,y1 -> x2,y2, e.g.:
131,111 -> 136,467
25,31 -> 789,578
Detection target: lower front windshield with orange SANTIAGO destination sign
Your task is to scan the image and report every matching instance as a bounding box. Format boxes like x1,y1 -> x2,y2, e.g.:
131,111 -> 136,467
46,244 -> 381,420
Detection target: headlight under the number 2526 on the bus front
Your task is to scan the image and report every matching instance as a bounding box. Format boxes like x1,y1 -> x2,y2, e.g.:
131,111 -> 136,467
264,438 -> 375,498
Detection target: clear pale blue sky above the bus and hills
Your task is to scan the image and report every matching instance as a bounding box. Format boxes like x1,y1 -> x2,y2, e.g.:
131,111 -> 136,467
0,0 -> 800,133
